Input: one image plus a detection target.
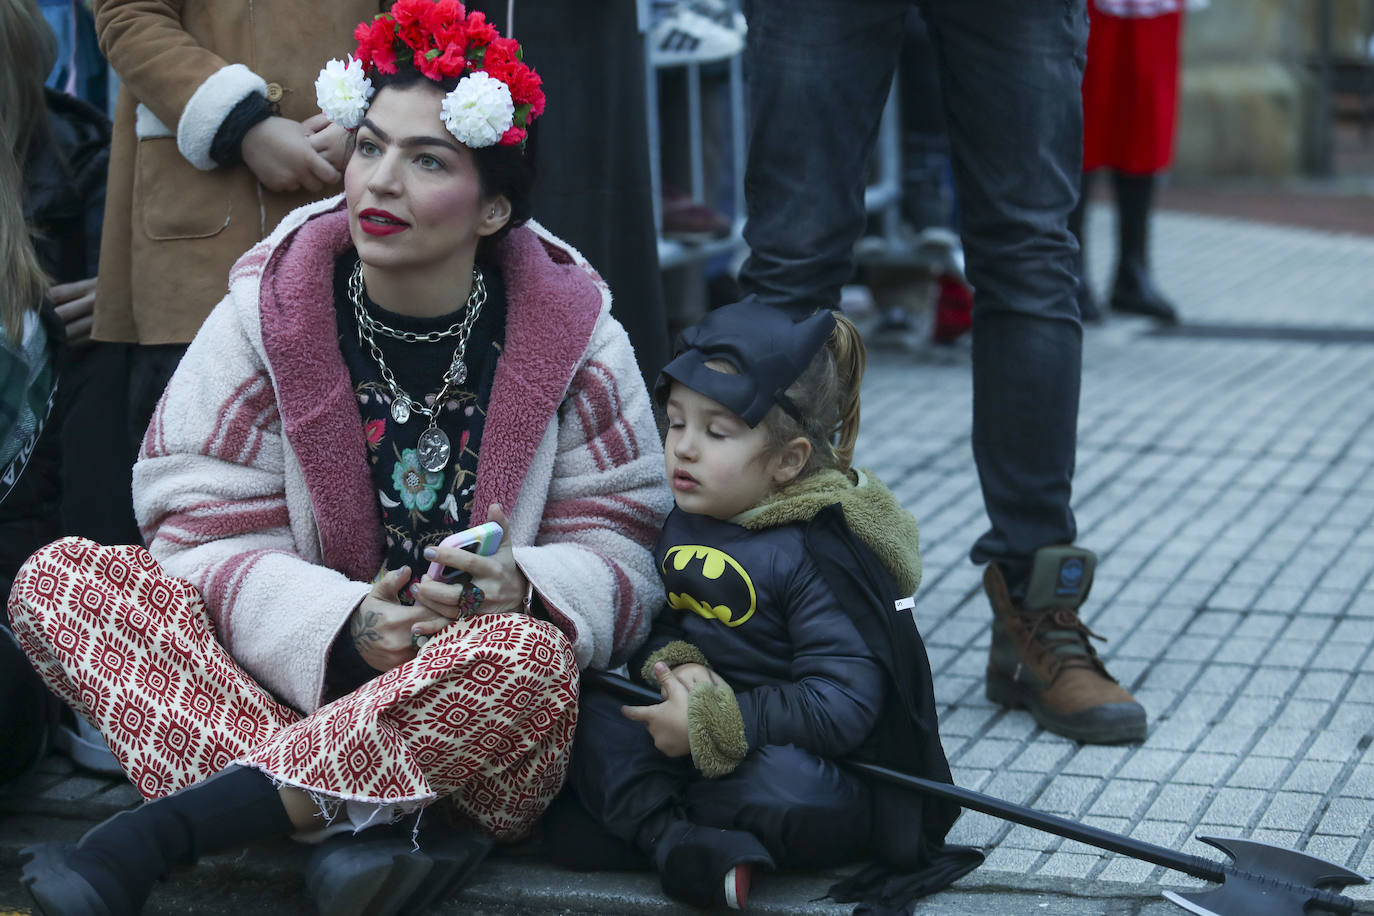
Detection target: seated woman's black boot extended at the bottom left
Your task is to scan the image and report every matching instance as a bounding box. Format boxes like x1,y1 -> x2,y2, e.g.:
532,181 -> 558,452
19,766 -> 294,916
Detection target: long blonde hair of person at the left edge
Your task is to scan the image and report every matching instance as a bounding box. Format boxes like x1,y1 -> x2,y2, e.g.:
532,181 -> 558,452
0,0 -> 58,345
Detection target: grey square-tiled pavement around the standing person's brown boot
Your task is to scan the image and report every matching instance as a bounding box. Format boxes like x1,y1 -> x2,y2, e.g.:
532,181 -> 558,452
0,207 -> 1374,916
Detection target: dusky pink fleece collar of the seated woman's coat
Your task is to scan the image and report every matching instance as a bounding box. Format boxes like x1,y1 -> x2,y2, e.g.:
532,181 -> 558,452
258,205 -> 603,581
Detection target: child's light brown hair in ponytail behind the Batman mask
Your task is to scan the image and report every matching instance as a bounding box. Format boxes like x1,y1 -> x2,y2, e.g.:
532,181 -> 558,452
763,312 -> 868,479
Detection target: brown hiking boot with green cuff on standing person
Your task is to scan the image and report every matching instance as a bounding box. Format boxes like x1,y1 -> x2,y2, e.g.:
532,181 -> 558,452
982,547 -> 1145,744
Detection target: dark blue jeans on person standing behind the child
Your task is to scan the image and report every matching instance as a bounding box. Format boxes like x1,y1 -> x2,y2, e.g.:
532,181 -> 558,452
741,0 -> 1088,586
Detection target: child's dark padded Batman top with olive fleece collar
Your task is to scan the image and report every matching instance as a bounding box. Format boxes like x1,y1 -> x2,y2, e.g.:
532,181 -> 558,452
631,471 -> 921,757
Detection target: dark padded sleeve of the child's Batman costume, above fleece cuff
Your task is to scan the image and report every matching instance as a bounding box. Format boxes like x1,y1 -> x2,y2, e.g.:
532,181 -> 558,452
736,556 -> 883,757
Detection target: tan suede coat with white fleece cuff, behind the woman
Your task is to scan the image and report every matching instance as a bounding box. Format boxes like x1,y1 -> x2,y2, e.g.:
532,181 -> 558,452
92,0 -> 389,343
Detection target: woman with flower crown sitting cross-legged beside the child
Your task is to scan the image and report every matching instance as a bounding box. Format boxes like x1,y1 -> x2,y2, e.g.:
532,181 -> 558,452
10,0 -> 669,916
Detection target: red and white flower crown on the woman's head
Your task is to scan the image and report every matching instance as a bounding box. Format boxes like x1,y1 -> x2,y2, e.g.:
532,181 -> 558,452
315,0 -> 544,150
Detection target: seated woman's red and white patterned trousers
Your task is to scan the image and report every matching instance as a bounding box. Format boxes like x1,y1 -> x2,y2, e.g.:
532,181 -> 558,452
10,538 -> 578,839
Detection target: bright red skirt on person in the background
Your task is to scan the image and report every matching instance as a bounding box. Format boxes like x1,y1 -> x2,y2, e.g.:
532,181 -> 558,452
1083,7 -> 1183,174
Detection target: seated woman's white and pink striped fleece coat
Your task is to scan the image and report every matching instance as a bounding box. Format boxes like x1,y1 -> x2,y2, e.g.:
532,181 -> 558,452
133,196 -> 671,713
